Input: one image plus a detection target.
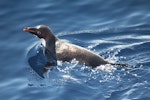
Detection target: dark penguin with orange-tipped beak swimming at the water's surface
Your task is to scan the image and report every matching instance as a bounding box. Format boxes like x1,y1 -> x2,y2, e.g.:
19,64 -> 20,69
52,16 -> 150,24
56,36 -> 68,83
23,25 -> 126,77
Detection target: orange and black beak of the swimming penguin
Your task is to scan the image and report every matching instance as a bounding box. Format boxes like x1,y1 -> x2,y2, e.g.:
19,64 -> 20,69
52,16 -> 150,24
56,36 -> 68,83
23,27 -> 41,38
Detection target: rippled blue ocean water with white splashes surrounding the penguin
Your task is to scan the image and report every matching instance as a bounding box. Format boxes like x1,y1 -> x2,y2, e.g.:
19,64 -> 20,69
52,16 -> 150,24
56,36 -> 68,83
0,0 -> 150,100
